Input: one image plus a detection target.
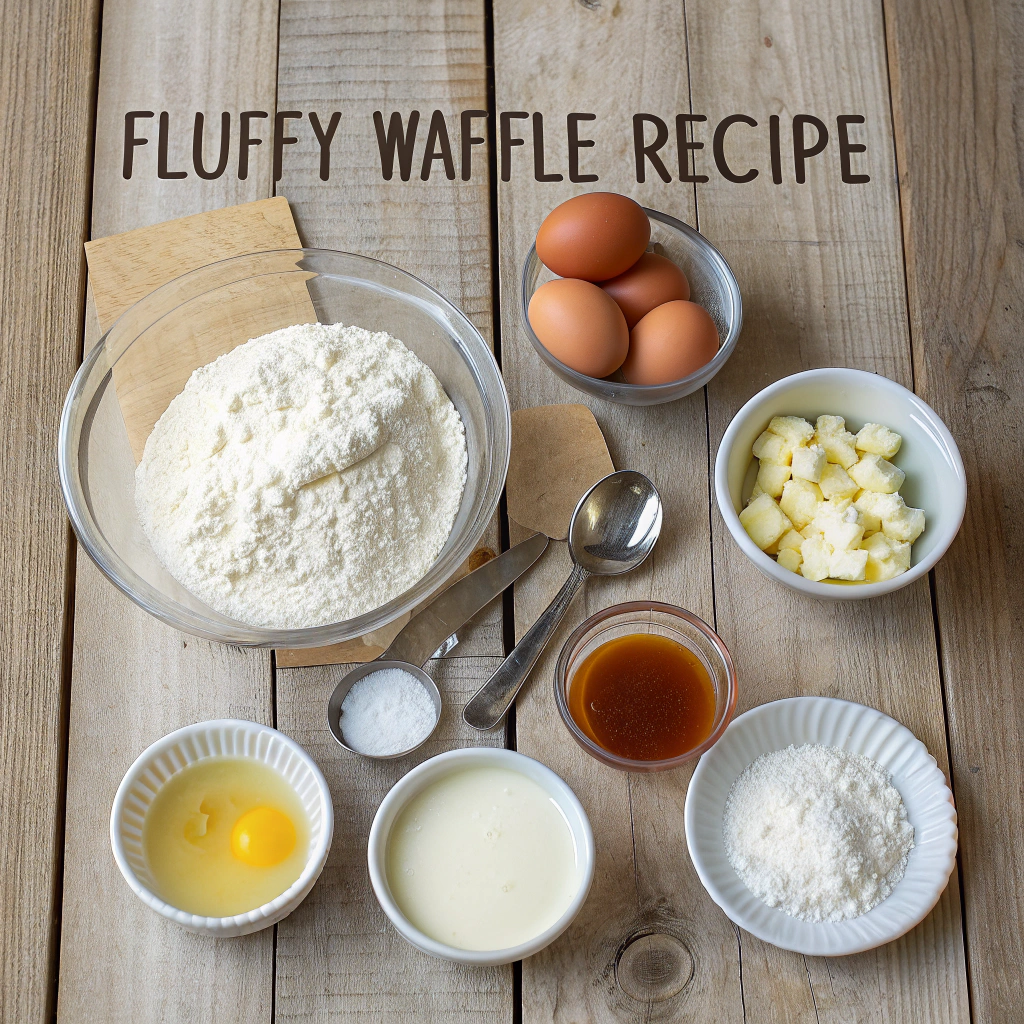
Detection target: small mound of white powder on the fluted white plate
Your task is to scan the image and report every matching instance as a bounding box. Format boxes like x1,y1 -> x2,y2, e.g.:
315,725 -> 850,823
723,743 -> 913,922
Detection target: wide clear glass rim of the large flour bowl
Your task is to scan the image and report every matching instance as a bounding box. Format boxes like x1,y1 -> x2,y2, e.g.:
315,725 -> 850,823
56,246 -> 512,648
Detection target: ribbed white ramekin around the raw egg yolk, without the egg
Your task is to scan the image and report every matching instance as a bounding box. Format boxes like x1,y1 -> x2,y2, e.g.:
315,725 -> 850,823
111,719 -> 334,938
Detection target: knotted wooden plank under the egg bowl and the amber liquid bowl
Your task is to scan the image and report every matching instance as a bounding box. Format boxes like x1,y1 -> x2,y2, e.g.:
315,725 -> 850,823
495,2 -> 742,1024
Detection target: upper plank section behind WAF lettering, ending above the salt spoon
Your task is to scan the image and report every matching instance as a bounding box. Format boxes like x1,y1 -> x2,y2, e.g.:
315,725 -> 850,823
276,0 -> 502,660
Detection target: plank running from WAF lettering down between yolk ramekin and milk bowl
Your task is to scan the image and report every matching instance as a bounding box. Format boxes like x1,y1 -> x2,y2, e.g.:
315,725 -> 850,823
275,0 -> 512,1024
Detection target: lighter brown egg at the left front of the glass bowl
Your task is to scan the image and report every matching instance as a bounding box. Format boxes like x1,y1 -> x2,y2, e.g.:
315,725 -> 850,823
527,278 -> 630,377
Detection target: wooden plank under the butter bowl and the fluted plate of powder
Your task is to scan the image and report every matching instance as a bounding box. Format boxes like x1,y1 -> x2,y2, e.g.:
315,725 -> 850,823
686,0 -> 969,1022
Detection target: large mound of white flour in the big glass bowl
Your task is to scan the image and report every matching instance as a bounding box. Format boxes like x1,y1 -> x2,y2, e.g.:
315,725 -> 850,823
135,324 -> 467,629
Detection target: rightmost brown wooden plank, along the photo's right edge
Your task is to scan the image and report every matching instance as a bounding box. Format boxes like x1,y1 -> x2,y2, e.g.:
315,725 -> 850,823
885,0 -> 1024,1024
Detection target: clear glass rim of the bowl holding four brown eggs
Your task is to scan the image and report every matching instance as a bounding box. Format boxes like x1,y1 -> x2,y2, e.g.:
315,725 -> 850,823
519,206 -> 743,395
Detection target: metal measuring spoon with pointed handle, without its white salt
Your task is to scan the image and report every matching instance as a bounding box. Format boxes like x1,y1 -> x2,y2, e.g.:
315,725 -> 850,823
327,534 -> 548,761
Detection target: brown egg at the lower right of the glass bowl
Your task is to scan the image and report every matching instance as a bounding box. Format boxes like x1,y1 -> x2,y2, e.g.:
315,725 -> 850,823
623,299 -> 718,384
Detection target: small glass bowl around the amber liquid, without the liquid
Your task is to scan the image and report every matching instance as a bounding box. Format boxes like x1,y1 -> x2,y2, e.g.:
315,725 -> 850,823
554,600 -> 738,772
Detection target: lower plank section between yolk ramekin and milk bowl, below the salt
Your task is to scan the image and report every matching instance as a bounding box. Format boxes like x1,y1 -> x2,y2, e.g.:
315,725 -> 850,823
274,657 -> 512,1024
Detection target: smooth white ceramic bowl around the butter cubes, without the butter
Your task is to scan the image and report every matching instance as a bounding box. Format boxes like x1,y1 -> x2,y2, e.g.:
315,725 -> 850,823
715,367 -> 967,601
